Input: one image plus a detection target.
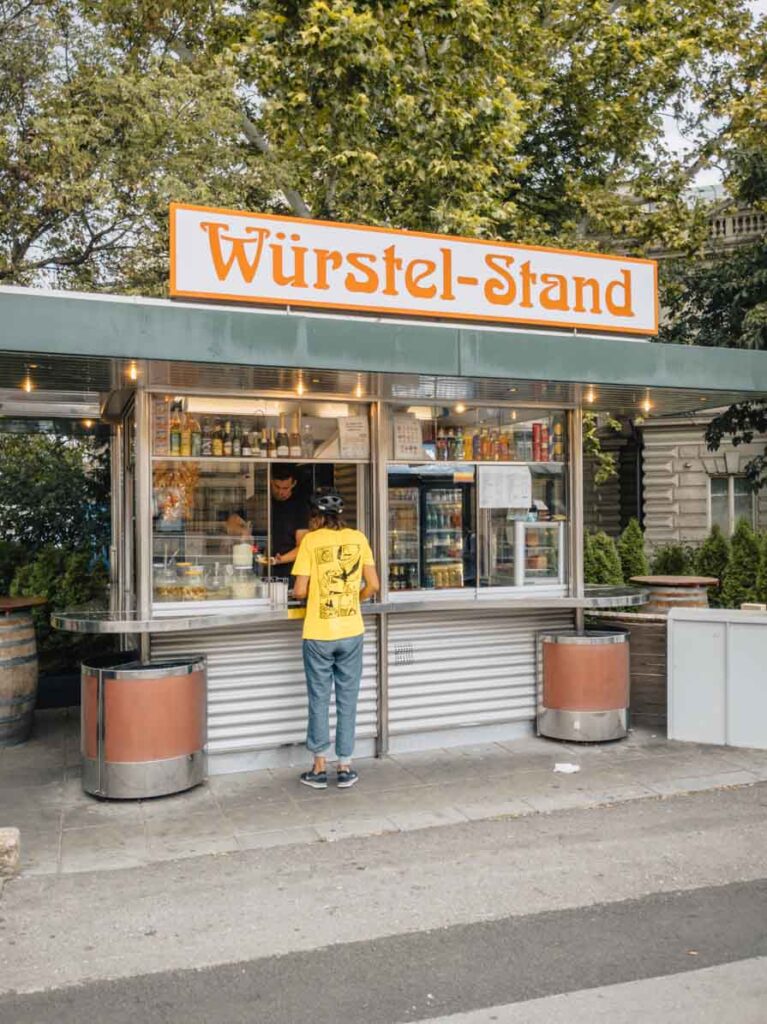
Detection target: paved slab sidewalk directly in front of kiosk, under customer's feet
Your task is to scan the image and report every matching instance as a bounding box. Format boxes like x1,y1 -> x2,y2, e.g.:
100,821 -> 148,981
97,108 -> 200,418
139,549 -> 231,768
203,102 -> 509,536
0,710 -> 767,876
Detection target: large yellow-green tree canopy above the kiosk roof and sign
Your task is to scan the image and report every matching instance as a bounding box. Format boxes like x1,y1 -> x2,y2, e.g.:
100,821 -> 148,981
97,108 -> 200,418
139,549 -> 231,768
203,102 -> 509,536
0,0 -> 763,294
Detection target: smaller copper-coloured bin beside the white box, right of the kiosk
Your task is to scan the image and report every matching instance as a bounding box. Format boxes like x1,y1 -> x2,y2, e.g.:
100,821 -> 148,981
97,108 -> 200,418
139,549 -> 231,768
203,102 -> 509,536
538,629 -> 629,742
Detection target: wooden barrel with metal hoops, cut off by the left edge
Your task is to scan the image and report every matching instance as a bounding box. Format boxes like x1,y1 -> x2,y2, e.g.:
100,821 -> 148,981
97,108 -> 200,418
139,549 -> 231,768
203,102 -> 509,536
0,612 -> 37,746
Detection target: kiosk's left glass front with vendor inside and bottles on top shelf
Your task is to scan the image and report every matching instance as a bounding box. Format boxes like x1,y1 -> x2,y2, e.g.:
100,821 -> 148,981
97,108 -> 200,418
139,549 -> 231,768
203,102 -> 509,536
152,395 -> 370,614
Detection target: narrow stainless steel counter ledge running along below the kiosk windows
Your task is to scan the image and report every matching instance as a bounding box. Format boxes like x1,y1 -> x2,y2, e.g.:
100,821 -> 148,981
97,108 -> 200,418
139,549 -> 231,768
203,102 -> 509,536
51,587 -> 648,634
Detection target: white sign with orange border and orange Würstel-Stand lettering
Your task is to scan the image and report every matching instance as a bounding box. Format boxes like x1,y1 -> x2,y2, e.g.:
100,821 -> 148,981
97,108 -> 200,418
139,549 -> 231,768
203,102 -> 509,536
170,204 -> 657,335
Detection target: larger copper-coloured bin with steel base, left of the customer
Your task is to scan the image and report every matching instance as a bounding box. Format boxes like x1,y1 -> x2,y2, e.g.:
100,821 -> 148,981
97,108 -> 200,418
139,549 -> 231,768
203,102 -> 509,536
81,652 -> 207,800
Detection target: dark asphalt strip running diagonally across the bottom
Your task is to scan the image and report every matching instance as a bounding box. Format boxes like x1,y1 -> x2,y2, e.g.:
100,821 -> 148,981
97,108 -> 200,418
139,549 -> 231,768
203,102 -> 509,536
0,879 -> 767,1024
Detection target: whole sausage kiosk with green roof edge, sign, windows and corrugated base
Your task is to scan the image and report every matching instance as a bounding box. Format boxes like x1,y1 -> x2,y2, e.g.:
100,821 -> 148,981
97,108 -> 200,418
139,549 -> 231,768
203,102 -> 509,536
5,207 -> 767,772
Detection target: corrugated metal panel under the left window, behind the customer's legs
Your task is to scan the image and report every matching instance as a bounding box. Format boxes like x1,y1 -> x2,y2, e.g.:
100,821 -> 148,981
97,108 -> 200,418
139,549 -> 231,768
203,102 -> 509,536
152,622 -> 377,754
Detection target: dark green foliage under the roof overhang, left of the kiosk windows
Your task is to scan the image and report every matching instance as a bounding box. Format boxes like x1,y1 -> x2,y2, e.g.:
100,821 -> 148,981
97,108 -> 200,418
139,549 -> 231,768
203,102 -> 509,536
0,434 -> 110,554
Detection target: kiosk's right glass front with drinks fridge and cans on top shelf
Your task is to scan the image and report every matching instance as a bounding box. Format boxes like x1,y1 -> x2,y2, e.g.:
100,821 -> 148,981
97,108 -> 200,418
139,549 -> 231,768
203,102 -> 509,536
387,403 -> 567,594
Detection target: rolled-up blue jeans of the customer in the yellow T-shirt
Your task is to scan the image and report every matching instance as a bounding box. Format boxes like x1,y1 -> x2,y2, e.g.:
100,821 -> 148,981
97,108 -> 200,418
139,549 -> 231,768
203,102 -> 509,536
303,633 -> 363,762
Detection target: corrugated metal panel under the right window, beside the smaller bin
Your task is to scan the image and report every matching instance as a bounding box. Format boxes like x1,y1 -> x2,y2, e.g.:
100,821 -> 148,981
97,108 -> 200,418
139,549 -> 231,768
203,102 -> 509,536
389,611 -> 572,736
